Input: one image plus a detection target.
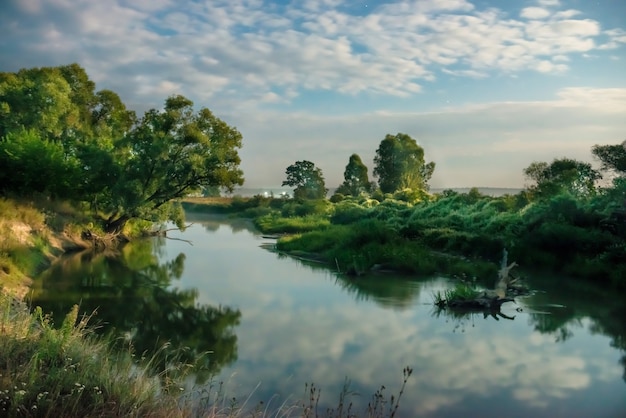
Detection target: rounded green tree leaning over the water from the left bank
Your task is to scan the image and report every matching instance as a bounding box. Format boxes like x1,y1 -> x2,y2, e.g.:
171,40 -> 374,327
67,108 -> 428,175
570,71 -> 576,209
102,96 -> 243,232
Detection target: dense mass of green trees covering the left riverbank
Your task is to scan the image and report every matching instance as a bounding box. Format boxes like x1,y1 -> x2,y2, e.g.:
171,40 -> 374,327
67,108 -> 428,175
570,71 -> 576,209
0,64 -> 243,232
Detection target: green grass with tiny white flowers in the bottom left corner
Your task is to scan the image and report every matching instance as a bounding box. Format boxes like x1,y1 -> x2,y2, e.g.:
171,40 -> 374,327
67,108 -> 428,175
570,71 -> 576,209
0,295 -> 181,417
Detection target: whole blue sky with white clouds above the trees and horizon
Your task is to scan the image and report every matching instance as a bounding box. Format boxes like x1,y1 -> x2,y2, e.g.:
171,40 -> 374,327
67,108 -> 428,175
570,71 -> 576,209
0,0 -> 626,188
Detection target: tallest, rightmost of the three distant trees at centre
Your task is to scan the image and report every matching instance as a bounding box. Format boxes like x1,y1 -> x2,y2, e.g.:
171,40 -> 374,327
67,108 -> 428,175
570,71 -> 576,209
374,133 -> 435,193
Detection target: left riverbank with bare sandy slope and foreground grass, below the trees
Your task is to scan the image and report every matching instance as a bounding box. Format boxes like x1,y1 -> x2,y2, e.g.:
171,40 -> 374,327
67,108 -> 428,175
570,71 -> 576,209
0,199 -> 410,418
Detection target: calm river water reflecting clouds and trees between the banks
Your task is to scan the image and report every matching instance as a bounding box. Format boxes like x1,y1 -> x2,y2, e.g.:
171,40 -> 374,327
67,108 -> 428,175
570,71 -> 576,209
33,215 -> 626,417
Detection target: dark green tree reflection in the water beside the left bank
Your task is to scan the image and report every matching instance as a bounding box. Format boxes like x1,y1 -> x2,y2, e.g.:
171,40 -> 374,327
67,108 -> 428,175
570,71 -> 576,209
31,235 -> 241,383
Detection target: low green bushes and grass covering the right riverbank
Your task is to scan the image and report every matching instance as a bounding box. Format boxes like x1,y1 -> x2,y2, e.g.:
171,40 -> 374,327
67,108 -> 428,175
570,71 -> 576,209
183,171 -> 626,291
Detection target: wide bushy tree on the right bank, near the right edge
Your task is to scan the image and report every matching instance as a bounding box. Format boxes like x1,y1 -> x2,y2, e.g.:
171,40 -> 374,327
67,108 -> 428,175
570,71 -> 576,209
524,158 -> 602,197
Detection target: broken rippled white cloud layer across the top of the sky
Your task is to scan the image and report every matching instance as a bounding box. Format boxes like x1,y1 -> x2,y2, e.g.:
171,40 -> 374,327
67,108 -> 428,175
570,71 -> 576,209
0,0 -> 623,106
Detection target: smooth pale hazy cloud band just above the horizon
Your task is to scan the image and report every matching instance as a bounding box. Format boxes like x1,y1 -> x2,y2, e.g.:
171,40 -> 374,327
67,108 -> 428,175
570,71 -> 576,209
233,87 -> 626,187
